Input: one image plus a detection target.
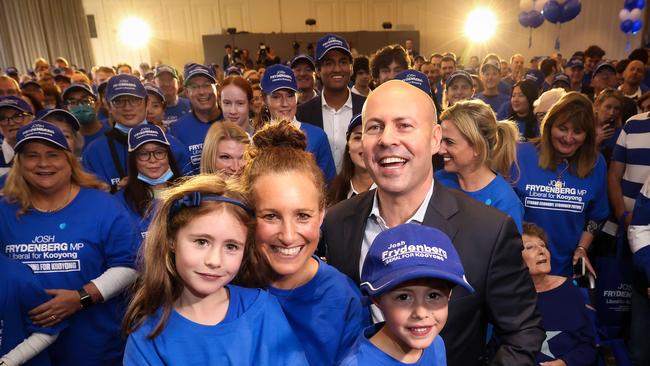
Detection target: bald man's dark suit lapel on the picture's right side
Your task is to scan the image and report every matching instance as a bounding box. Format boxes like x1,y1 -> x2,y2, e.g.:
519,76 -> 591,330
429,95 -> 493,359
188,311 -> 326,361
423,182 -> 459,241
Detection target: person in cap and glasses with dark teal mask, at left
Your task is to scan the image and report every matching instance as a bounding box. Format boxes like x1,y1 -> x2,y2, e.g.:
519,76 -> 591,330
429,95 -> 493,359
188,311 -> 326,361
62,83 -> 110,151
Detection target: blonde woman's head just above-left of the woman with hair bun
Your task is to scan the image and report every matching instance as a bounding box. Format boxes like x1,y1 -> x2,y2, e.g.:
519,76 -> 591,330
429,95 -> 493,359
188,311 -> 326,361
201,122 -> 250,177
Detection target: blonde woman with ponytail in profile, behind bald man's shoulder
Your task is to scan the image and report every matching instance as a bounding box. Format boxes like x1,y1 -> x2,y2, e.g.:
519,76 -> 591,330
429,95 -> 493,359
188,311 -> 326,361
436,100 -> 524,232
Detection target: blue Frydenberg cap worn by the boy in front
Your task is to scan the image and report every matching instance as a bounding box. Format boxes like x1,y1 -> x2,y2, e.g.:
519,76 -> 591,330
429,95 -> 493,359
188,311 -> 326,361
361,223 -> 474,296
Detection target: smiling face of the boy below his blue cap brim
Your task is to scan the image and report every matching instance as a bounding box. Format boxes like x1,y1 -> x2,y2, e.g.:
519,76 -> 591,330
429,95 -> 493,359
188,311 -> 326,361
375,278 -> 451,352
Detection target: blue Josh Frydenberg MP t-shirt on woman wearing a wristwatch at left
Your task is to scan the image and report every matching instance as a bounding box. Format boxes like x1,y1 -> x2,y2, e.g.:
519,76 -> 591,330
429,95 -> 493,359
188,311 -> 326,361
0,188 -> 140,365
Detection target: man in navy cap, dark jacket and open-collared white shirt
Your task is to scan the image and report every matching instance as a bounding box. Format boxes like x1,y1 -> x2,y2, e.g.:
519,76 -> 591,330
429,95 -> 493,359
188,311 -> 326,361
296,34 -> 366,171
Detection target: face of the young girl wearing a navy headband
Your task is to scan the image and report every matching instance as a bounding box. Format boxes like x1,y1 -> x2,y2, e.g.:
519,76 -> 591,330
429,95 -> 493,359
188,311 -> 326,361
174,208 -> 247,299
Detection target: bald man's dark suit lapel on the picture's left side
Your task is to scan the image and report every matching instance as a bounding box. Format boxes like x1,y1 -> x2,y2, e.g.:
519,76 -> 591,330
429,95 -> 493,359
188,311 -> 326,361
343,189 -> 375,283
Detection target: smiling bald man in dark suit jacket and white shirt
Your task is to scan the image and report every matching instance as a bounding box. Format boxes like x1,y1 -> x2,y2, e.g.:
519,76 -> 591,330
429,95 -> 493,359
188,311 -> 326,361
321,80 -> 545,366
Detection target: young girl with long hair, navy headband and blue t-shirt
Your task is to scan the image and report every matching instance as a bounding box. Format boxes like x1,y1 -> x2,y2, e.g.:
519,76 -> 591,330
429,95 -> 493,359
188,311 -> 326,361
124,175 -> 307,365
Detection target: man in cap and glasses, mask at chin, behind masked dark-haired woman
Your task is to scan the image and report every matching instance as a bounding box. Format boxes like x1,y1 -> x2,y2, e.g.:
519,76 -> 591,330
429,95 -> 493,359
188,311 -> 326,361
83,74 -> 192,193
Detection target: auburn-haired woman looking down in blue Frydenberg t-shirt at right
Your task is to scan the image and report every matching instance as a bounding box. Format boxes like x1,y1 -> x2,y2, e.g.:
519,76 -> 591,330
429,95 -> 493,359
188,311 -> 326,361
513,89 -> 609,277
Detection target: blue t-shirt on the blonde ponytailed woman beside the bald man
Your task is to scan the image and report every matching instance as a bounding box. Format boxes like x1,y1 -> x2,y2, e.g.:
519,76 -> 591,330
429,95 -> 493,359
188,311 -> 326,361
435,170 -> 524,233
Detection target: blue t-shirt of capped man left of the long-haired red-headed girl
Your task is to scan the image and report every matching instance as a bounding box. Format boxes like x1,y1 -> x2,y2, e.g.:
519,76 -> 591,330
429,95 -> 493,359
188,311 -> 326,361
169,112 -> 222,174
